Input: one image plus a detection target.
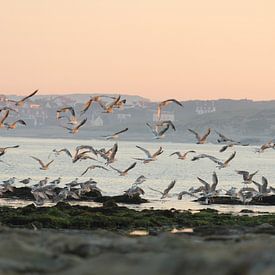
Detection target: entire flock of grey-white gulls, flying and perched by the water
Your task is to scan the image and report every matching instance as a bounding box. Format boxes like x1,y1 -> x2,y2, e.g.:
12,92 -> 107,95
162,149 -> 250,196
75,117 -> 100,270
0,90 -> 275,205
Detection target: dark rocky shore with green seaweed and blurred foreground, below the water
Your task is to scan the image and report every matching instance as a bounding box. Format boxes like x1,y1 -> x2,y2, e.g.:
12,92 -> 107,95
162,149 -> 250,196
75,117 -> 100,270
0,204 -> 275,275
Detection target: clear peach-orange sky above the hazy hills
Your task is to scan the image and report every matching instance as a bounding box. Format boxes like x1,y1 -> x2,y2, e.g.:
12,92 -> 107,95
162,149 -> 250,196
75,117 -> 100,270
0,0 -> 275,100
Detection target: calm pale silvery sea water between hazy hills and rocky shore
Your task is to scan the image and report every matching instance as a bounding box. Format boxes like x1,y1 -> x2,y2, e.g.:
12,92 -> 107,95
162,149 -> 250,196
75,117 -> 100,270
0,137 -> 275,212
